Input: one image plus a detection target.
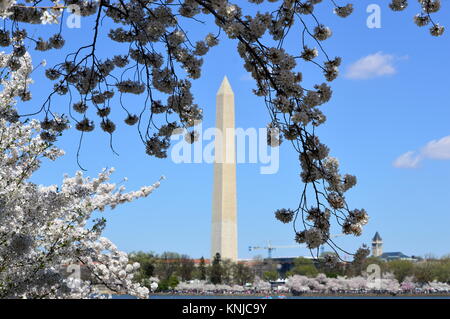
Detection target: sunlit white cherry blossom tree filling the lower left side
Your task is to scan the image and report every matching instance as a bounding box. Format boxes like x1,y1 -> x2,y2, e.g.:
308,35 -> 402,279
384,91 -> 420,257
0,53 -> 159,298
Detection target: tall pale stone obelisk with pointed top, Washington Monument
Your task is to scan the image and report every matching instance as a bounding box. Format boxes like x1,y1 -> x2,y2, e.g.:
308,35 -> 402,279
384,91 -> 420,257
211,77 -> 237,262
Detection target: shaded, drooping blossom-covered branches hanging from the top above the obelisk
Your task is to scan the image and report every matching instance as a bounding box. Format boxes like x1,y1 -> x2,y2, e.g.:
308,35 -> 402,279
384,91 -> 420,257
0,0 -> 444,262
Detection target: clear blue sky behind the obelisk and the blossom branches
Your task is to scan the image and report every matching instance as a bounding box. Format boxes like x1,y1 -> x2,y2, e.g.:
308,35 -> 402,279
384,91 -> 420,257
20,1 -> 450,258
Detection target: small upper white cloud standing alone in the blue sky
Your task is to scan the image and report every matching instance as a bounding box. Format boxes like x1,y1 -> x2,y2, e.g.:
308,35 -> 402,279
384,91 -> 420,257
345,52 -> 397,80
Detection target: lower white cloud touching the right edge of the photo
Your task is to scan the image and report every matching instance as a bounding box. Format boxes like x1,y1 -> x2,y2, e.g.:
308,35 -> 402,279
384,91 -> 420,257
393,136 -> 450,168
